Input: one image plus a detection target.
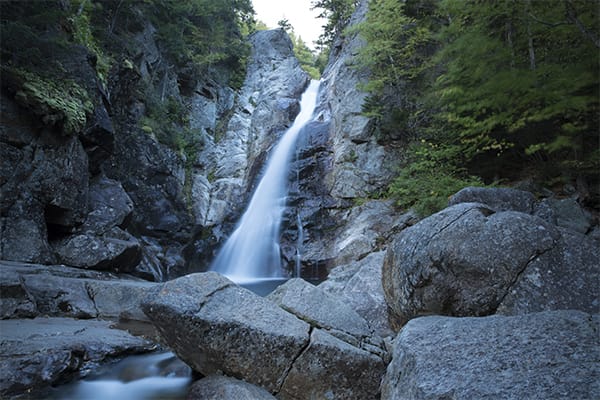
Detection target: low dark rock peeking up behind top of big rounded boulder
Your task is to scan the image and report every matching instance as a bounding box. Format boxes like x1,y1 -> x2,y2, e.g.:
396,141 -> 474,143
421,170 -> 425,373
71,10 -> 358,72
448,187 -> 536,214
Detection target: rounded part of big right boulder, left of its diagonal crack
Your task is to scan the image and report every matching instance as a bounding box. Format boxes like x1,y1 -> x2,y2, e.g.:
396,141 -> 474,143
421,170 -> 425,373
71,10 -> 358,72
383,203 -> 560,322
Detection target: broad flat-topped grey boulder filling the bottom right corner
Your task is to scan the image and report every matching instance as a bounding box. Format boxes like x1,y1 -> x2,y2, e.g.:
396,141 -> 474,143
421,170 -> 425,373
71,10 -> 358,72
381,310 -> 600,400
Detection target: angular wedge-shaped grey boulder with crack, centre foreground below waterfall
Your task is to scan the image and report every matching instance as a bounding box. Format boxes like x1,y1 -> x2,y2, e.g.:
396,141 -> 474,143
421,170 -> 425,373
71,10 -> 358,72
143,272 -> 385,399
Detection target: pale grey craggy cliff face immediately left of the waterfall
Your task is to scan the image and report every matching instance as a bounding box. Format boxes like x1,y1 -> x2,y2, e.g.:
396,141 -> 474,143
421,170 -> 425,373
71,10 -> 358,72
186,29 -> 309,270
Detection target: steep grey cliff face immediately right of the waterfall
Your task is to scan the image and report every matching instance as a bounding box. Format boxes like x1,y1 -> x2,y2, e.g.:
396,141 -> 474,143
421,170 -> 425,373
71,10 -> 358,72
282,0 -> 408,279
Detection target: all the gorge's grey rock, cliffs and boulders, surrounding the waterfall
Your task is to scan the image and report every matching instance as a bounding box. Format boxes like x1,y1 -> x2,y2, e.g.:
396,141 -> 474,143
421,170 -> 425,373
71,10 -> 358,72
0,0 -> 600,400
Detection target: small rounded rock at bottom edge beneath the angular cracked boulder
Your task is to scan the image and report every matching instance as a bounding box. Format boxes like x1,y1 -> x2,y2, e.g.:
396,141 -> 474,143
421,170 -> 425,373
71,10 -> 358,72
187,375 -> 275,400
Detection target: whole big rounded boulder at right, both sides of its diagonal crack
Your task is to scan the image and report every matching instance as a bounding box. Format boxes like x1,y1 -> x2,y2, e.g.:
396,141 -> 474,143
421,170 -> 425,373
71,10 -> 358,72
383,203 -> 600,322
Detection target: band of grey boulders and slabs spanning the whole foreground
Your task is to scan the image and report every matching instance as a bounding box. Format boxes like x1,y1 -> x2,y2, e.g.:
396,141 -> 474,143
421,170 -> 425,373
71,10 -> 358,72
0,188 -> 600,399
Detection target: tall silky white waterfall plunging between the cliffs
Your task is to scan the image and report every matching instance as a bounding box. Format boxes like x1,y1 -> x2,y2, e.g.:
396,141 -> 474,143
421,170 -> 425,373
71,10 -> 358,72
210,80 -> 319,283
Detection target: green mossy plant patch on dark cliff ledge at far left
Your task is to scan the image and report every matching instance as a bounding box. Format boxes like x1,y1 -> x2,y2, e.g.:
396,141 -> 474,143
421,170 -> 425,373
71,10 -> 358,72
2,68 -> 94,135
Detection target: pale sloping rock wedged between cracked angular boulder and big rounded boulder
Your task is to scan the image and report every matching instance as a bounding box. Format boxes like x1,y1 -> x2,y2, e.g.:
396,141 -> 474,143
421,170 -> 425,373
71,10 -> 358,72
318,251 -> 394,337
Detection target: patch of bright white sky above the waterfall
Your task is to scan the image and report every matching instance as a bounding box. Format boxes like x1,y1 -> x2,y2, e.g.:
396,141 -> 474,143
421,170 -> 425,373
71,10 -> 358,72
252,0 -> 325,49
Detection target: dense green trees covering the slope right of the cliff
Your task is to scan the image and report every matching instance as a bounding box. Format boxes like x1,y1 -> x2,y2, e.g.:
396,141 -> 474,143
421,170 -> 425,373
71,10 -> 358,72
359,0 -> 600,216
